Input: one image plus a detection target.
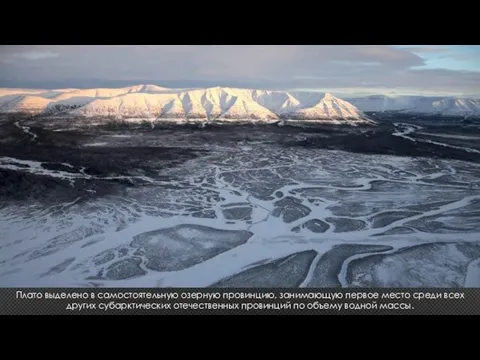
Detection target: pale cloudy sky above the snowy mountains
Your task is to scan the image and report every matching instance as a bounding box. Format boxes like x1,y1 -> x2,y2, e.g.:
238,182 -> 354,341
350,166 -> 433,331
0,45 -> 480,97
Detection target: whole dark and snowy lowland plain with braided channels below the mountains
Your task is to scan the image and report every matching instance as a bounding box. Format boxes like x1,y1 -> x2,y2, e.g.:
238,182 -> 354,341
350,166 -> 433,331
0,114 -> 480,287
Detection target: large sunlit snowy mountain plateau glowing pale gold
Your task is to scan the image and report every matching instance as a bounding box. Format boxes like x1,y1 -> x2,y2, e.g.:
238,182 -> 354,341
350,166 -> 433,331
0,85 -> 368,122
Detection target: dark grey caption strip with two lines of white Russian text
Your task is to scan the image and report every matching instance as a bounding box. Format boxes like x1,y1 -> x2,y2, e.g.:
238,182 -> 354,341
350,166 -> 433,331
0,288 -> 480,315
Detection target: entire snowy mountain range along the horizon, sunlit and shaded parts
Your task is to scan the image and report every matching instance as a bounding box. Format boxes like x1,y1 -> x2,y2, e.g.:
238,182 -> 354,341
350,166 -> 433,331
0,85 -> 480,124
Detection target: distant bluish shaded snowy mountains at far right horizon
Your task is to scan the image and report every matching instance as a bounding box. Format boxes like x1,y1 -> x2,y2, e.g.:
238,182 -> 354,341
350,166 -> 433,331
346,95 -> 480,116
